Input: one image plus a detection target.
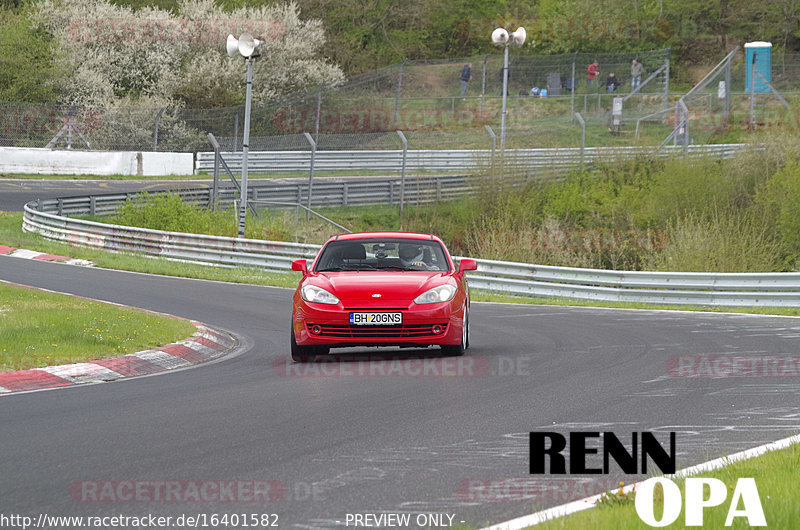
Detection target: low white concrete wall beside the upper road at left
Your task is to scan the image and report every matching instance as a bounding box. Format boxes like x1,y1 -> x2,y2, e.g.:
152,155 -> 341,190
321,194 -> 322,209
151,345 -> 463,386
0,147 -> 194,177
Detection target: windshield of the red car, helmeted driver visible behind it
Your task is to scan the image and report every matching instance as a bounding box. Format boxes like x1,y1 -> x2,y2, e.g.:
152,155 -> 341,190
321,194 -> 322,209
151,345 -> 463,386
314,238 -> 450,272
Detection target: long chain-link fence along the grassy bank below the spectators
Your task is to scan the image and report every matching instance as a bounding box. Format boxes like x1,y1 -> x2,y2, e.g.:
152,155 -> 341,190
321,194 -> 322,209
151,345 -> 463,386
0,50 -> 800,152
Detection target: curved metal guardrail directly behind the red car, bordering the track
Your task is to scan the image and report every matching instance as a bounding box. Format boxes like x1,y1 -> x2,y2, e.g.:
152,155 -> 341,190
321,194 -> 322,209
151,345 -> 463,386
23,197 -> 800,306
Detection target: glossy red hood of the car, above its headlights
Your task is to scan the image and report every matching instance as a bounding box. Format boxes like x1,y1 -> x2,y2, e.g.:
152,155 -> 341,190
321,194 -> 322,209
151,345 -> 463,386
309,271 -> 450,300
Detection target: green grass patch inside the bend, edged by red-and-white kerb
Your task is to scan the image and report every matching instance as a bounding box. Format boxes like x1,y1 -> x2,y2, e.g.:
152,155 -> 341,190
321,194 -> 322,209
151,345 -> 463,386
0,283 -> 196,372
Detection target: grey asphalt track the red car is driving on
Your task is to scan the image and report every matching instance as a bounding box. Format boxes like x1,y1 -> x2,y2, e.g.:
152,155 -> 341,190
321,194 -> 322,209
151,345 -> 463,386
0,180 -> 800,528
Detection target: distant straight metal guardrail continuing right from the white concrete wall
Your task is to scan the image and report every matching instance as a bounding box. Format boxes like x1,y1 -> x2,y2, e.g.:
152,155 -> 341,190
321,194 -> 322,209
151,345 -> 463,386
195,144 -> 746,174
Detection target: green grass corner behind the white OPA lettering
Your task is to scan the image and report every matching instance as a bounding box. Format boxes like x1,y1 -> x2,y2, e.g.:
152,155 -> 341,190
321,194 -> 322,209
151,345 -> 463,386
531,444 -> 800,530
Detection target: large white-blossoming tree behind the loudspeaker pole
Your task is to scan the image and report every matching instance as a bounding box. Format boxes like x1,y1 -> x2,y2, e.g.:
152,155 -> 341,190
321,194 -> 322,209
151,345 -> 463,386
36,0 -> 343,108
